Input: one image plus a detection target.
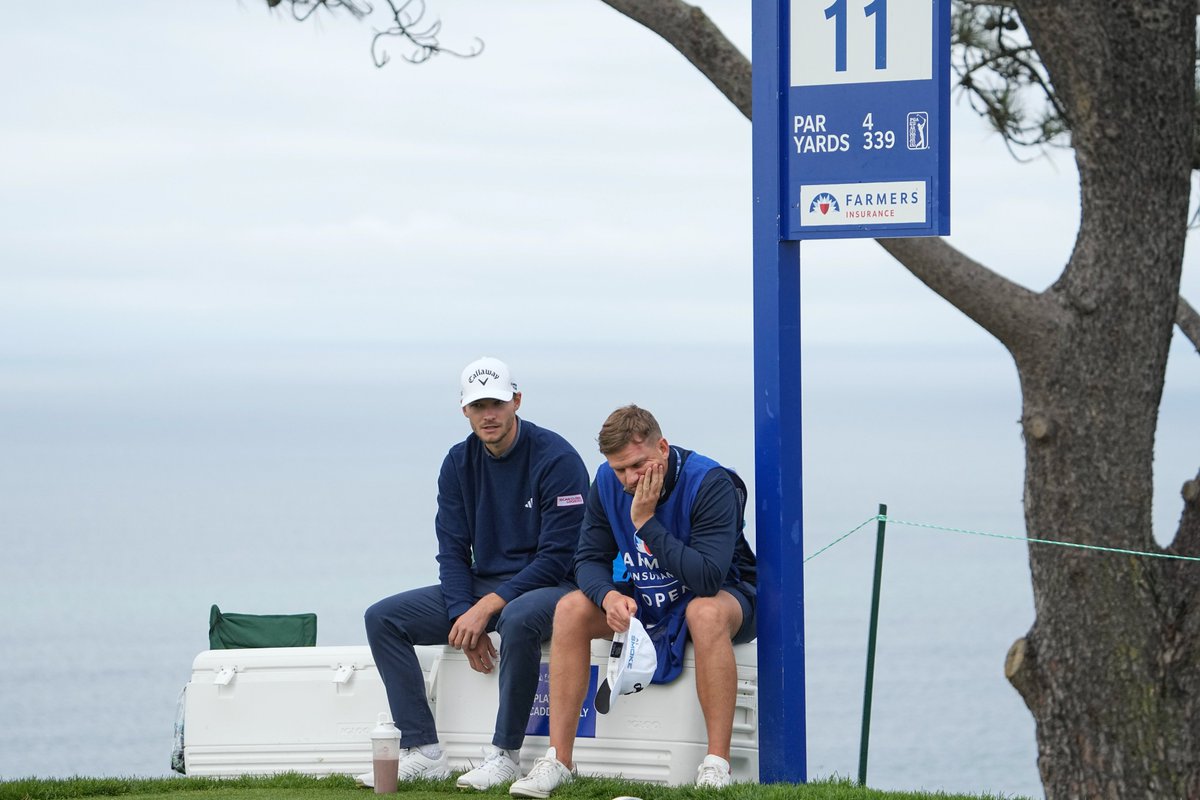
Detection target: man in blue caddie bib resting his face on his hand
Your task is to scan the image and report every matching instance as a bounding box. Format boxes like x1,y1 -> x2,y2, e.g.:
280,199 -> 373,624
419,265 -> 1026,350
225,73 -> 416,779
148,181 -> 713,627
509,405 -> 757,799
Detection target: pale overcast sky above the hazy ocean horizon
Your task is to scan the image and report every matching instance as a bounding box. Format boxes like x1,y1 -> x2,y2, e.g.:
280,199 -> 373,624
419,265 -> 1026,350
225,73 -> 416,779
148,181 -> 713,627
0,0 -> 1200,519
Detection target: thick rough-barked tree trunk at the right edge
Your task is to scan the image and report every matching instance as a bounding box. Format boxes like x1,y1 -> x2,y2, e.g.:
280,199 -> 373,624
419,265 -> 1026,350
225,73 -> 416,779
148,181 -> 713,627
1006,0 -> 1200,800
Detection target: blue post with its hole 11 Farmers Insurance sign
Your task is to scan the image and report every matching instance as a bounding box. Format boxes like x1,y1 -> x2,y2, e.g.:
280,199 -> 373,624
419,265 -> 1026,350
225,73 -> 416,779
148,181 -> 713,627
752,0 -> 950,783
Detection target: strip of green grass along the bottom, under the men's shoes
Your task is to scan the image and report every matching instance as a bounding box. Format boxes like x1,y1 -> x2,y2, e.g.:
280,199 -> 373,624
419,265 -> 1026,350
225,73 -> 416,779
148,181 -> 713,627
0,775 -> 1021,800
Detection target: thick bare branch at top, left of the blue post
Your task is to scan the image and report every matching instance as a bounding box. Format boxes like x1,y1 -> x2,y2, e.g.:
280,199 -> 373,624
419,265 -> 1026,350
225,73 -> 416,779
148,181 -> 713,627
604,0 -> 750,119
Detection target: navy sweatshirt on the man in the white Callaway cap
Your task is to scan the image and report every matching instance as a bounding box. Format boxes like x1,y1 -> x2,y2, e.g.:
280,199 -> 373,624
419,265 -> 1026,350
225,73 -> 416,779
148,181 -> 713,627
434,417 -> 588,619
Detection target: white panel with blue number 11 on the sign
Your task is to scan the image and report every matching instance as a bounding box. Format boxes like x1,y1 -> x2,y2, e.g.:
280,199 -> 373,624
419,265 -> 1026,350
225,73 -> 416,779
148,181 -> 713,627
790,0 -> 934,86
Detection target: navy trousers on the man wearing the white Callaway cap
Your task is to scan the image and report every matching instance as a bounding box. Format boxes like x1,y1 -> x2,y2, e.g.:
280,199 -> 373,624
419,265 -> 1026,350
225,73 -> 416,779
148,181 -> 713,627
366,578 -> 575,750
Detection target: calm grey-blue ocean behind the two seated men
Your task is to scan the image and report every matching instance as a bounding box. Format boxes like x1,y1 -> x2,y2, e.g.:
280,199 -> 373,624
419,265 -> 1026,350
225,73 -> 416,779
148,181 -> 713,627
0,335 -> 1193,798
